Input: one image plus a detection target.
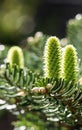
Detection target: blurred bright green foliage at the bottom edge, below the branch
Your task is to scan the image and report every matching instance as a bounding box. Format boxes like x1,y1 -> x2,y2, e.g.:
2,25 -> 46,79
13,113 -> 46,130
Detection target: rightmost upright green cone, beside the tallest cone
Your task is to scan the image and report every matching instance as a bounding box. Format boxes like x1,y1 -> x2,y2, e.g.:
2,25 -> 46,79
63,45 -> 78,83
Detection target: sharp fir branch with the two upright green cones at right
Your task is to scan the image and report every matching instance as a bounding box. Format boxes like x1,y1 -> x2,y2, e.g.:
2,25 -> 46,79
0,34 -> 82,128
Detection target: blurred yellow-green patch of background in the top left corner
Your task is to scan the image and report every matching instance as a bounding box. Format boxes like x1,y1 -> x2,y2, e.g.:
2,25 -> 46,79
0,0 -> 38,44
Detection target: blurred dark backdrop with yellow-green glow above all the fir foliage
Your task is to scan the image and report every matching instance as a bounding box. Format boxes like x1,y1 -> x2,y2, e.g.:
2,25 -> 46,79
0,0 -> 82,45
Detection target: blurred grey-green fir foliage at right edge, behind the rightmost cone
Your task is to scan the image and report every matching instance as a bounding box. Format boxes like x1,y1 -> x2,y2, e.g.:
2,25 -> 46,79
67,14 -> 82,60
